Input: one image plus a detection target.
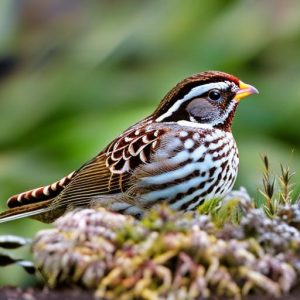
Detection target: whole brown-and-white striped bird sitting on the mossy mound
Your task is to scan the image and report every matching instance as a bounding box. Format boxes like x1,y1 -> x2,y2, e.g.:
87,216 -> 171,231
0,71 -> 258,223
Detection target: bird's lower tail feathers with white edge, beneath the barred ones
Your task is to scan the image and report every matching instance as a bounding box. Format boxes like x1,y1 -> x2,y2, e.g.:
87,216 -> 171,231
0,199 -> 52,223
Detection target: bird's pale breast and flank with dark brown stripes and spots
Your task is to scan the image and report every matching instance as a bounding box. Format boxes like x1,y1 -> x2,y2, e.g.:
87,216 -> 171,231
134,129 -> 239,210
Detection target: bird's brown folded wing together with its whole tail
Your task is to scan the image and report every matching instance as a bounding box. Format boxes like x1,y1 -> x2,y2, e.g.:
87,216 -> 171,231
0,123 -> 165,222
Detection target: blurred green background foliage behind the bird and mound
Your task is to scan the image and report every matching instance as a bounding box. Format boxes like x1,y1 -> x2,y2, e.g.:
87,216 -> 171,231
0,0 -> 300,286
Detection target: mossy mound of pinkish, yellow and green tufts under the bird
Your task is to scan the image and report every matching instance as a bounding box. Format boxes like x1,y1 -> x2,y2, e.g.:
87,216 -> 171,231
32,192 -> 300,299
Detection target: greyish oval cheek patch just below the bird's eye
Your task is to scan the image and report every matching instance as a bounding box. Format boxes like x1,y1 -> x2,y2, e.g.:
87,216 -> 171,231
186,98 -> 220,122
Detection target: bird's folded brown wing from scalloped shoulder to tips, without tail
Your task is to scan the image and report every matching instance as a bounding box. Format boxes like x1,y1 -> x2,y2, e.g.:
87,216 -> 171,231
53,128 -> 164,207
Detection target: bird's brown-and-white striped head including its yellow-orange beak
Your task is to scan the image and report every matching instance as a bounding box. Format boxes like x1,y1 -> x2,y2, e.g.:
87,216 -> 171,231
154,71 -> 258,130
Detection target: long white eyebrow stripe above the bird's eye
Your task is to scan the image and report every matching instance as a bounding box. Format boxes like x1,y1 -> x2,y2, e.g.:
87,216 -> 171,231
155,81 -> 230,122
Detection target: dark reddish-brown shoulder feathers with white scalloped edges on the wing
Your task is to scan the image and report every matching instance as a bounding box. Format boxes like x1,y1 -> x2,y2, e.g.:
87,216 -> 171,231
106,128 -> 164,174
